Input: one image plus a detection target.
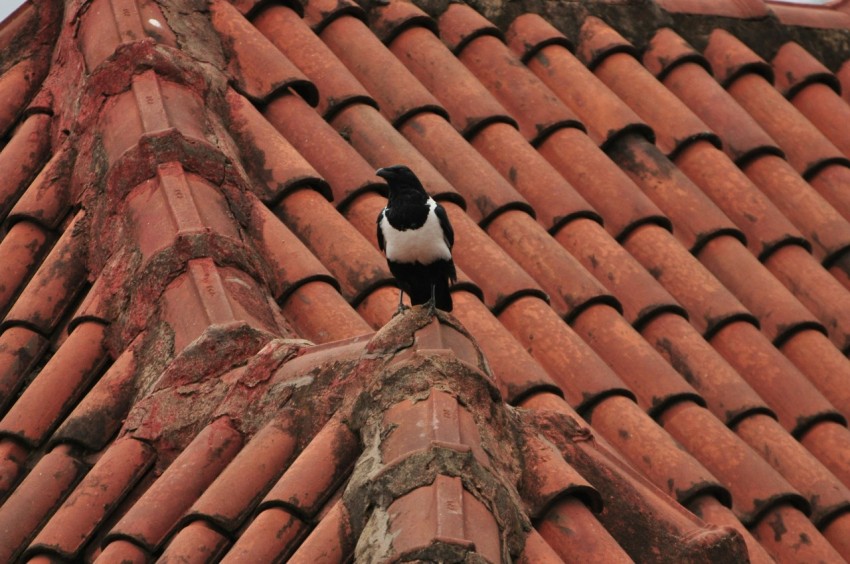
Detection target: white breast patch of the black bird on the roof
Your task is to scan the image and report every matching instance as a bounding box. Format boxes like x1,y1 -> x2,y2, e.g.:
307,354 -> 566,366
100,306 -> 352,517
380,198 -> 452,264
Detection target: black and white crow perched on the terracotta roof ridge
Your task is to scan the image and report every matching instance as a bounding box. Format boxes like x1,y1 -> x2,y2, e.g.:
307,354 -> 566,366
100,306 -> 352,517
376,165 -> 457,311
